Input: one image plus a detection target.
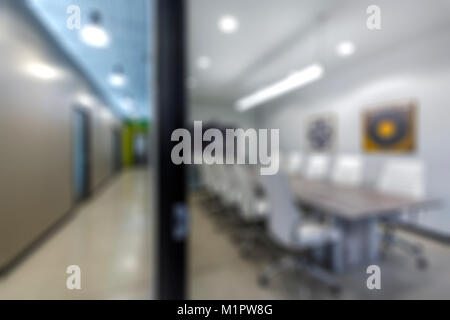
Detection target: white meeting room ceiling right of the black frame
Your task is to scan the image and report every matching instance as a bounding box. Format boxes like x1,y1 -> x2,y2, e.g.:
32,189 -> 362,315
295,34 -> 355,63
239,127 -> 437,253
189,0 -> 450,108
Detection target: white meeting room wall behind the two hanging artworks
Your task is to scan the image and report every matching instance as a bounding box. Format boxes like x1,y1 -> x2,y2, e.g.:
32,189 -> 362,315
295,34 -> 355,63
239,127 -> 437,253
258,28 -> 450,235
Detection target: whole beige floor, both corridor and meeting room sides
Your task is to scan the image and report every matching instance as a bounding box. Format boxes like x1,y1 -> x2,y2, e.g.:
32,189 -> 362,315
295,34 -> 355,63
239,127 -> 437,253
0,170 -> 450,299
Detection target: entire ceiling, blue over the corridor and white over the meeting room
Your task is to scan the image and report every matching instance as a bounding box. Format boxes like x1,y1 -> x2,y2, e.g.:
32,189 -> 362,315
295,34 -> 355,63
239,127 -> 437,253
24,0 -> 450,117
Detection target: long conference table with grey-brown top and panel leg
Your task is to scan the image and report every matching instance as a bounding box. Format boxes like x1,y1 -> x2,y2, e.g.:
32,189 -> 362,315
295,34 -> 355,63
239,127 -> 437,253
289,177 -> 438,272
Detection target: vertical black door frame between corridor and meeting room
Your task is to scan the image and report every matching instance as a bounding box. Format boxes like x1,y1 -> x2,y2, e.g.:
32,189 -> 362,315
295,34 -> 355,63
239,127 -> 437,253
155,0 -> 188,300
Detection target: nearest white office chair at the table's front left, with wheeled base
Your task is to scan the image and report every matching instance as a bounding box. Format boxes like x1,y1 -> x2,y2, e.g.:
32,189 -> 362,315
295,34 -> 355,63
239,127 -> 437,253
259,174 -> 340,292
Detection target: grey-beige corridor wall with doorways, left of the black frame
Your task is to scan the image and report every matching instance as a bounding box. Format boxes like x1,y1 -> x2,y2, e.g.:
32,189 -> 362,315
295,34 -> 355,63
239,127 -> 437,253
0,1 -> 119,269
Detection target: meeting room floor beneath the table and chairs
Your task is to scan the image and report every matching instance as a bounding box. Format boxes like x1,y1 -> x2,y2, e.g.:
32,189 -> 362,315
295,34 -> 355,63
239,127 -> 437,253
190,192 -> 450,299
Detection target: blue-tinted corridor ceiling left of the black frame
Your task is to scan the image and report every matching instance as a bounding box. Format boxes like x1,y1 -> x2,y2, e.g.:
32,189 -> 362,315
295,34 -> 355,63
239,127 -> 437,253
28,0 -> 152,119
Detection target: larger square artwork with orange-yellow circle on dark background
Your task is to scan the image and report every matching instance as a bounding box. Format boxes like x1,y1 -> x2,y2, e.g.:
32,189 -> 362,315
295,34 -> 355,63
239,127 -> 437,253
362,100 -> 418,153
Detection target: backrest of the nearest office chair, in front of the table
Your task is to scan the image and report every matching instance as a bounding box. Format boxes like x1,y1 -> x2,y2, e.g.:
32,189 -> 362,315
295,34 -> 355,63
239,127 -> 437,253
261,173 -> 302,247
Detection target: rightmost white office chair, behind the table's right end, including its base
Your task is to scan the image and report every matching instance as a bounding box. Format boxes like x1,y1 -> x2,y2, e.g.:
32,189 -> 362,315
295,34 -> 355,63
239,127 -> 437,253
377,159 -> 428,269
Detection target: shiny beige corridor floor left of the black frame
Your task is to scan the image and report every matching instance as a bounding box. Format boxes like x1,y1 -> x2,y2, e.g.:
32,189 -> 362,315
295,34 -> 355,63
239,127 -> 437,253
0,169 -> 153,299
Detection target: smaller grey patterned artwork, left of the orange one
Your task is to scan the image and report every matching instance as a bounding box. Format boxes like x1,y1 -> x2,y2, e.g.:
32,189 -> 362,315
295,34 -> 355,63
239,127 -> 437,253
306,113 -> 337,152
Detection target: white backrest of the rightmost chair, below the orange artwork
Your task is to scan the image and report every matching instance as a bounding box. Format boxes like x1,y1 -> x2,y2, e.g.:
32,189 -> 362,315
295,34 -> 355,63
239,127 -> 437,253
377,159 -> 425,198
